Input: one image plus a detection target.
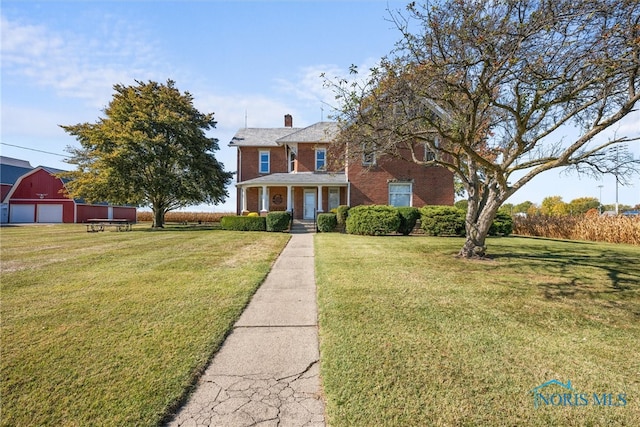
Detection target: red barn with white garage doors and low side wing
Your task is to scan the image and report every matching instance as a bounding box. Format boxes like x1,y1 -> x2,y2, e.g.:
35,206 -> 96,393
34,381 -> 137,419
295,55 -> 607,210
3,161 -> 136,223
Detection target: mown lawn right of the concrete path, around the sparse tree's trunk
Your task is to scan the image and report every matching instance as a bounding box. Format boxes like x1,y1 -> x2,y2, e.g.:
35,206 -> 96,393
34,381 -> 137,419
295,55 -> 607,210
315,233 -> 640,427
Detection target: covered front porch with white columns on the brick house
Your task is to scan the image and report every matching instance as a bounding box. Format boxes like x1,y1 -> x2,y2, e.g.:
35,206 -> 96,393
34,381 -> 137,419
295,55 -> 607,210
236,172 -> 349,219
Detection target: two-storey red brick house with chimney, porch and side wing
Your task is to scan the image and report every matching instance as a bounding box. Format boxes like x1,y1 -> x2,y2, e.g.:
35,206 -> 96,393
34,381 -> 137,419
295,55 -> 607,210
229,114 -> 454,219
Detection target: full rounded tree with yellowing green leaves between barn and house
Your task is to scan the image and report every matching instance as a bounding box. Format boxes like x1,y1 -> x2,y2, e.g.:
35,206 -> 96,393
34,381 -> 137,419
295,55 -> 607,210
61,80 -> 233,227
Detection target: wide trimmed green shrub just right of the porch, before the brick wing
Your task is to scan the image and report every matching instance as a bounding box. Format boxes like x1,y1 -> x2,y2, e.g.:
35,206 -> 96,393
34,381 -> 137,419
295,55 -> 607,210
346,205 -> 400,236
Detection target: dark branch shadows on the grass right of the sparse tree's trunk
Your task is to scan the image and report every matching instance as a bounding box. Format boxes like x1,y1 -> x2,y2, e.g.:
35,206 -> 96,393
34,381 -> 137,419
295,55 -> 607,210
493,238 -> 640,316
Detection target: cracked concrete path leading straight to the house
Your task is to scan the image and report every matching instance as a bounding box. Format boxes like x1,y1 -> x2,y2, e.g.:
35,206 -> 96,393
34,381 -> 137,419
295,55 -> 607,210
168,234 -> 325,427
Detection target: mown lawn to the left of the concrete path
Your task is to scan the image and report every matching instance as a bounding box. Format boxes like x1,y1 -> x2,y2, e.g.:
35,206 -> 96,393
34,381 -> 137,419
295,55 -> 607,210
0,224 -> 288,426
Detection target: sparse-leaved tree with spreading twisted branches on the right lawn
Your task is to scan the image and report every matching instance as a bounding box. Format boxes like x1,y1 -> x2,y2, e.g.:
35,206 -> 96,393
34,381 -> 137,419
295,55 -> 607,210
326,0 -> 640,257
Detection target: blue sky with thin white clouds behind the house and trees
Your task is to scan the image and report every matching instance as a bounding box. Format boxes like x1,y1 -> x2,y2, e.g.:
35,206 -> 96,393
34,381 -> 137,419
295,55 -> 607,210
0,0 -> 640,211
